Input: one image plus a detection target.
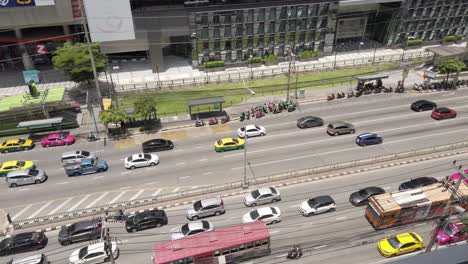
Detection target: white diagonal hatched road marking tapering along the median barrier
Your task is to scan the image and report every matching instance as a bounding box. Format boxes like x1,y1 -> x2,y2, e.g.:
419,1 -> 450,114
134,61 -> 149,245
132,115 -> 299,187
5,186 -> 201,222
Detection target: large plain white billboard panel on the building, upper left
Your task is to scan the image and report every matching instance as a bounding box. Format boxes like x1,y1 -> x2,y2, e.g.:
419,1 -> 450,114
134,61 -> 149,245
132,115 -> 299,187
83,0 -> 135,42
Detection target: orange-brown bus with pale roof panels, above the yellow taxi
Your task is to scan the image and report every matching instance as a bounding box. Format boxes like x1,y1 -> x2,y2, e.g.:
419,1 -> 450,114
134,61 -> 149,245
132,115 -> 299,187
365,183 -> 468,229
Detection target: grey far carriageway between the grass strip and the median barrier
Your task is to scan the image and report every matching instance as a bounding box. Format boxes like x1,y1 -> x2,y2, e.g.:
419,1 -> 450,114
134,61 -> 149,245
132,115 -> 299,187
0,87 -> 468,221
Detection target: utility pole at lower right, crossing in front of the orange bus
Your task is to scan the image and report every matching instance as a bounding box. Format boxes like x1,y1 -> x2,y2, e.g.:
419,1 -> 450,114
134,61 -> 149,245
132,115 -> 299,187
425,160 -> 468,253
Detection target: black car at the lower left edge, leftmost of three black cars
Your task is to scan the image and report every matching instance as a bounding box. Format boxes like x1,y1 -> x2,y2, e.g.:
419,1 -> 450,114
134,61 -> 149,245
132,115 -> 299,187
0,232 -> 49,256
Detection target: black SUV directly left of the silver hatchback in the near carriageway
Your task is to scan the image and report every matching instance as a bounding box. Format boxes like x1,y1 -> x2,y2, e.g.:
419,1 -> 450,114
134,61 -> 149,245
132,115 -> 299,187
125,210 -> 168,233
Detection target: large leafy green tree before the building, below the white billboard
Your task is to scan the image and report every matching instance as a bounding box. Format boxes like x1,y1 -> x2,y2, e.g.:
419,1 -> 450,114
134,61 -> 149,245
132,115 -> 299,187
52,43 -> 106,83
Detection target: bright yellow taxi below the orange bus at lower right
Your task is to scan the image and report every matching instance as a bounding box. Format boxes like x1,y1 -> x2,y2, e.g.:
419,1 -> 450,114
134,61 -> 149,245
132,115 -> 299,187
377,232 -> 423,258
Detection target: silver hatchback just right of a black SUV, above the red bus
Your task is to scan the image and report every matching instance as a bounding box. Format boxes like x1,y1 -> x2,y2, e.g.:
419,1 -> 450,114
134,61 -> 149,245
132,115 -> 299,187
186,197 -> 226,220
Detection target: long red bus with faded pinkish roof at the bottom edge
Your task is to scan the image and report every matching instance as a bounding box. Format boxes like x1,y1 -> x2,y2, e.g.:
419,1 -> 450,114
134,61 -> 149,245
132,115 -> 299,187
152,221 -> 271,264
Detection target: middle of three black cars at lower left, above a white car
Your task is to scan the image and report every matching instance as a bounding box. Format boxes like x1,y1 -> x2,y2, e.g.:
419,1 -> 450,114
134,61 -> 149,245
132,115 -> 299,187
58,220 -> 102,246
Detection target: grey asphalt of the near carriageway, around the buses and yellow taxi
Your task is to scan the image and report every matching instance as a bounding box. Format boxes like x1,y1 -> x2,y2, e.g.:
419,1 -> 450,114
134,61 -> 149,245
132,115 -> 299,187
0,155 -> 468,264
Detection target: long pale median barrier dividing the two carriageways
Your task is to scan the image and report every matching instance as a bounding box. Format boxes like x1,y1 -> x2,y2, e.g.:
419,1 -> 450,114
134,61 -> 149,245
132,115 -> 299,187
13,142 -> 468,229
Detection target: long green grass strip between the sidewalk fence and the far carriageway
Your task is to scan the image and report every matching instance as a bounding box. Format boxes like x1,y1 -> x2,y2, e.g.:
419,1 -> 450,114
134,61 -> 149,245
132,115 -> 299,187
122,64 -> 398,117
